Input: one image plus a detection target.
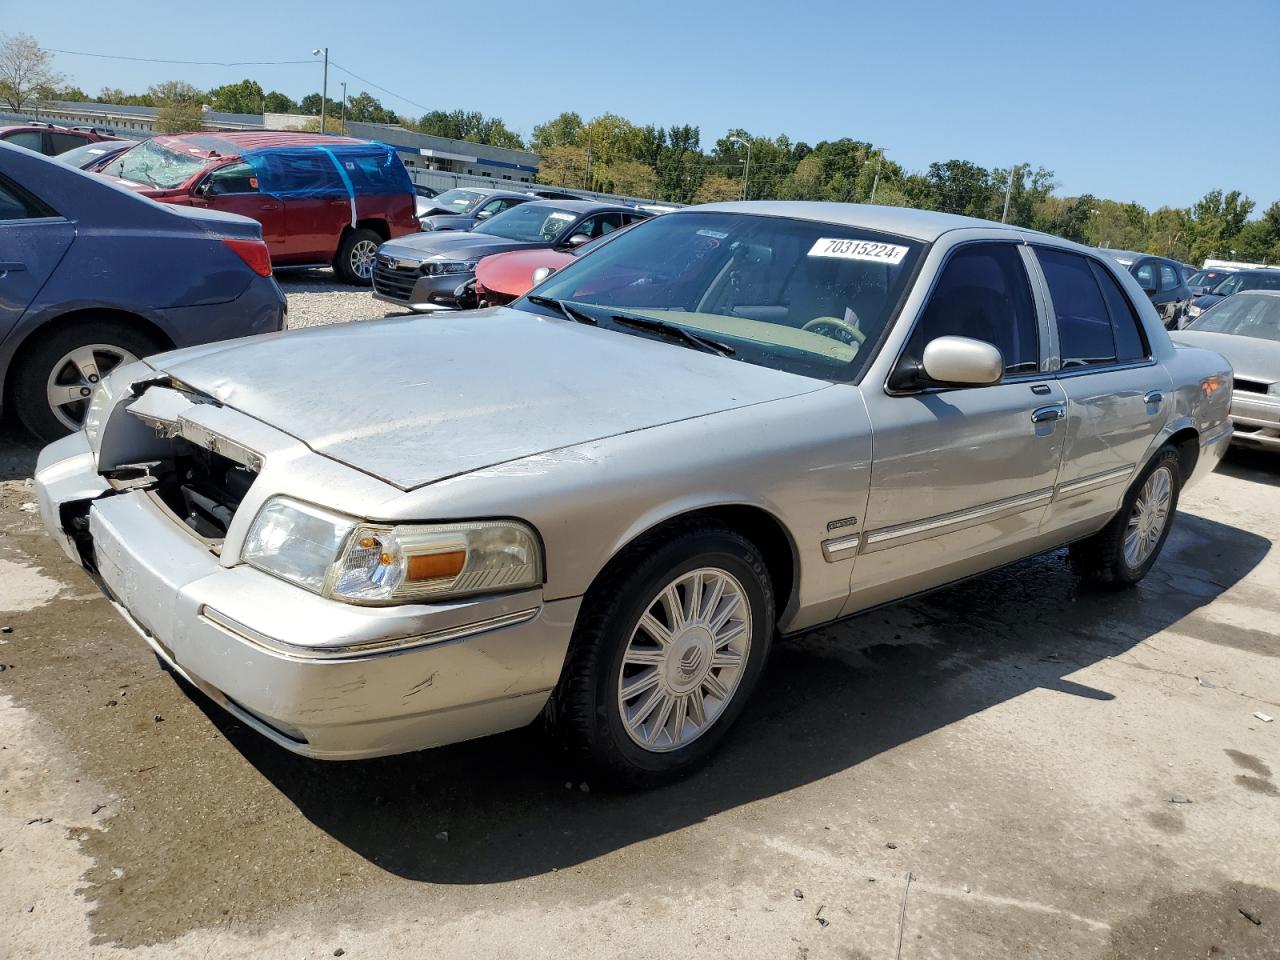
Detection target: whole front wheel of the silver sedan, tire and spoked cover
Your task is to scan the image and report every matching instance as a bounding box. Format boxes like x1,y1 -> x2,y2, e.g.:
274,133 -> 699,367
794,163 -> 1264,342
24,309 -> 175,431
549,527 -> 774,787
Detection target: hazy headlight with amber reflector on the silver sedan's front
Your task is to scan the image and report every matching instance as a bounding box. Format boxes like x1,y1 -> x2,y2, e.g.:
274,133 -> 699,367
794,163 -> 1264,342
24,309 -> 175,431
241,497 -> 543,604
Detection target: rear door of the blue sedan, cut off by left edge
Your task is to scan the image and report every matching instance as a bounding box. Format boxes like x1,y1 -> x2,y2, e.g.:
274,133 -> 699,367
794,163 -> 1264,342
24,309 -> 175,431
0,175 -> 76,339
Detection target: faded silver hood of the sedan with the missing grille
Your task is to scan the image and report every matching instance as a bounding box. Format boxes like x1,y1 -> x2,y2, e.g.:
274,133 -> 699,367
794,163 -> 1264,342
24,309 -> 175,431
148,308 -> 828,490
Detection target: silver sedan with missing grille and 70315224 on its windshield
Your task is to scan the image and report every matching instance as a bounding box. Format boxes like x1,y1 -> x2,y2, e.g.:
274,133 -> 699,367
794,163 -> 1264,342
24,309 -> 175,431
36,202 -> 1231,785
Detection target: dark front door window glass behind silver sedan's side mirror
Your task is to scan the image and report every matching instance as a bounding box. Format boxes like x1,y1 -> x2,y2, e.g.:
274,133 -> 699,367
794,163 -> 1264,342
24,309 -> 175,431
906,243 -> 1039,374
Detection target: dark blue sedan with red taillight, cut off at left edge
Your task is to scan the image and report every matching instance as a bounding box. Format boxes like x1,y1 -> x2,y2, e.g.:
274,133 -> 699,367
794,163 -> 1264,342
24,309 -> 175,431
0,143 -> 285,440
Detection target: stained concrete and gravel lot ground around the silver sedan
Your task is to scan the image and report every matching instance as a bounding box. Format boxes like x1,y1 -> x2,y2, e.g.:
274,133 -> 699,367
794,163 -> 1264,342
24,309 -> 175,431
0,295 -> 1280,960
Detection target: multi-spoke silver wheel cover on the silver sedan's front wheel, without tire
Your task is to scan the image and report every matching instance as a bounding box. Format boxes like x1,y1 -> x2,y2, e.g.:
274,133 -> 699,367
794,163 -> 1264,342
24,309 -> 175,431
618,567 -> 751,753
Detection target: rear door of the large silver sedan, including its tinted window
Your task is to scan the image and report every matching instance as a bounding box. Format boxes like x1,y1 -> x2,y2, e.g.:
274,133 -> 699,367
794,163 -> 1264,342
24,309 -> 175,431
1036,247 -> 1172,532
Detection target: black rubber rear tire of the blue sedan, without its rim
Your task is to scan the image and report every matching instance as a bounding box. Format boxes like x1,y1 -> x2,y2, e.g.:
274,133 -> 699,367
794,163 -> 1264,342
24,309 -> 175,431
12,317 -> 164,443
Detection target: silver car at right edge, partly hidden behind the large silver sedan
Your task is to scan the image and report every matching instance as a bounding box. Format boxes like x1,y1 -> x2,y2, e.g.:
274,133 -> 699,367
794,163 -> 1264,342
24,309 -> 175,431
1174,291 -> 1280,451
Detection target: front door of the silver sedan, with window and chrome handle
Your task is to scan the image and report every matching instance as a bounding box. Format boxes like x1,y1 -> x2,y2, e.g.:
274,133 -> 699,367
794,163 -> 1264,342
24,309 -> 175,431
845,242 -> 1066,613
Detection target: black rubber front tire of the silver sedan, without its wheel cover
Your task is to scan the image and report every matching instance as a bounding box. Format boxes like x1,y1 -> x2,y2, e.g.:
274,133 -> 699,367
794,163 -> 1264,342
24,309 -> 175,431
547,526 -> 776,788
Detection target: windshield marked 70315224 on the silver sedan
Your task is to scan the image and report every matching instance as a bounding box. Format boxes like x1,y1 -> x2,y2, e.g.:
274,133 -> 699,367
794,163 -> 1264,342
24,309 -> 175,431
517,211 -> 924,380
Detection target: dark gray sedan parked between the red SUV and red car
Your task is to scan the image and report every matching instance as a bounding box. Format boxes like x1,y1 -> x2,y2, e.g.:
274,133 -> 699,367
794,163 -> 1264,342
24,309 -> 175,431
374,200 -> 653,311
